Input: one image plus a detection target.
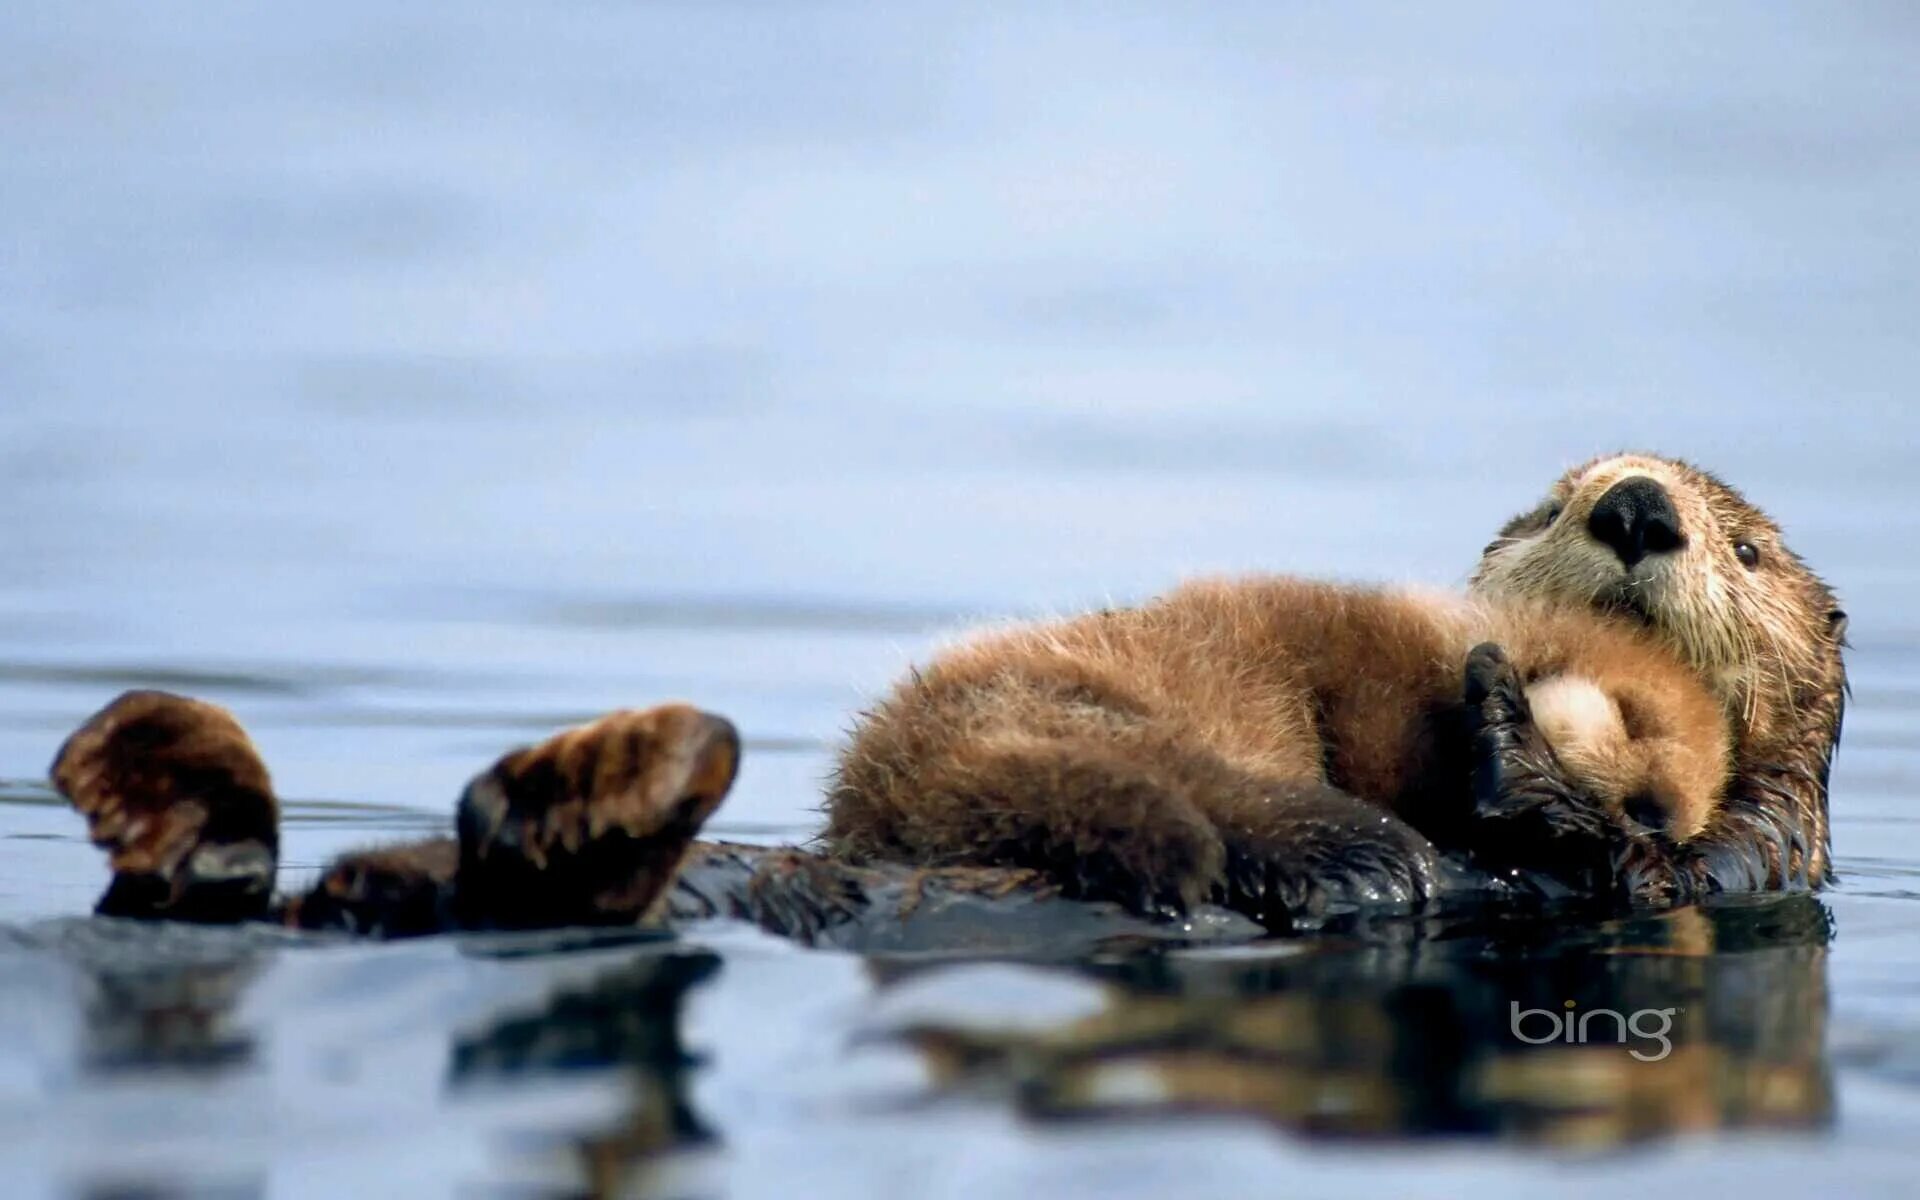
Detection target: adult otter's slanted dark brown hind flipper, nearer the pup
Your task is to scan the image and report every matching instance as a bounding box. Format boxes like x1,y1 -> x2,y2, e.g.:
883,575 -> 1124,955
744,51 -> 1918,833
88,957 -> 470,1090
455,705 -> 739,929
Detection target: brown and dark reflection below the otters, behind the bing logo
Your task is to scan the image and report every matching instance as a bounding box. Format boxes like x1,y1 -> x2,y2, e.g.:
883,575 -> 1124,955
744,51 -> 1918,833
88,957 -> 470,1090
876,895 -> 1834,1146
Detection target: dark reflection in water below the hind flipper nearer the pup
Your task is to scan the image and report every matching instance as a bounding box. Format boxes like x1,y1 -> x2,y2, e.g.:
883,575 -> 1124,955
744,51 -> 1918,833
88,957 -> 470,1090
449,952 -> 720,1196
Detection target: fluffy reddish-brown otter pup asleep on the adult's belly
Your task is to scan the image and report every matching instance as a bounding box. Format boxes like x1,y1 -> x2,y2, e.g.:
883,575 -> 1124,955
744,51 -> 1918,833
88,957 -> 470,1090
824,580 -> 1726,918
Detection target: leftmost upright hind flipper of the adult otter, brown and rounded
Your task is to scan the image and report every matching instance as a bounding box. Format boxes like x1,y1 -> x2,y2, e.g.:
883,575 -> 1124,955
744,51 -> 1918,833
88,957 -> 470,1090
52,691 -> 280,922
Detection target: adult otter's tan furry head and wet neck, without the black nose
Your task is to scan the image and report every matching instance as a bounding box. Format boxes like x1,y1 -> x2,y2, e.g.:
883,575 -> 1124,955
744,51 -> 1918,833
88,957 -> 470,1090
1473,455 -> 1847,889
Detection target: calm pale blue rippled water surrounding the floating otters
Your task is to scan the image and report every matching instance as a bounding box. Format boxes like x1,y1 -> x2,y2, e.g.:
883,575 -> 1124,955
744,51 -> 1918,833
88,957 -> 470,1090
0,4 -> 1920,1196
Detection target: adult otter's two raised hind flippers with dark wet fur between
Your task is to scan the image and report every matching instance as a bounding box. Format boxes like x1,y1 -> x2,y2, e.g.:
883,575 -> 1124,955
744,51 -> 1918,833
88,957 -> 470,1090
54,691 -> 739,935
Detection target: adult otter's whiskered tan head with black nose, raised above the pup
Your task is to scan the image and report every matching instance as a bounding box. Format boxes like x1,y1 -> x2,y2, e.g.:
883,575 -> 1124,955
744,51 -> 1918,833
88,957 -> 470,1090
1473,455 -> 1847,764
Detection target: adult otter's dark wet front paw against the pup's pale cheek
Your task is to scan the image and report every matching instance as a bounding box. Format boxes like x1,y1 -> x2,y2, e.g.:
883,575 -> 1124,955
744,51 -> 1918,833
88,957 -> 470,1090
1465,641 -> 1615,874
